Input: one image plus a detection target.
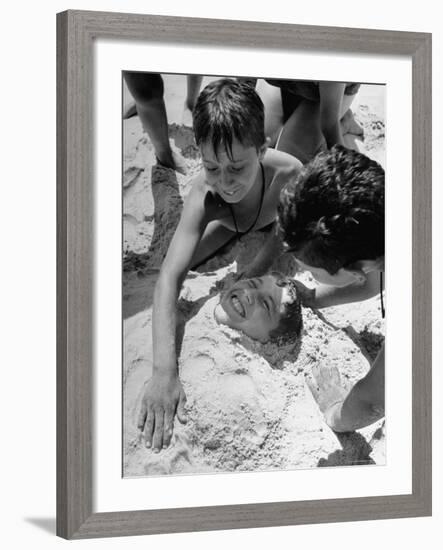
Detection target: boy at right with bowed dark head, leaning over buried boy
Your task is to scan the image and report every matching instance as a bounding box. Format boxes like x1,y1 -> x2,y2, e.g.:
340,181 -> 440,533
278,145 -> 385,432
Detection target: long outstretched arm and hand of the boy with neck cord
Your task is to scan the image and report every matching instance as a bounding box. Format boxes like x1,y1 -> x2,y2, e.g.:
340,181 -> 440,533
138,191 -> 206,451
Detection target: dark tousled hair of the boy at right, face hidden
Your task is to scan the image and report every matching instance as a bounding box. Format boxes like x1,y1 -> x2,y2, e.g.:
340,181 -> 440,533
278,145 -> 385,275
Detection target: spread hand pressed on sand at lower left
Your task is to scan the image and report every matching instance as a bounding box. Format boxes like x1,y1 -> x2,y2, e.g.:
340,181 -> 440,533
137,372 -> 187,452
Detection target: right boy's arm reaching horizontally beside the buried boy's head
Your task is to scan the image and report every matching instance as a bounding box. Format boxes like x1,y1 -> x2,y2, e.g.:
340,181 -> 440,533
299,271 -> 380,309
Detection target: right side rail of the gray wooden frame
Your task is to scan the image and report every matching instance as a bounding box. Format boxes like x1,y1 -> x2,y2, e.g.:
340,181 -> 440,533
412,35 -> 432,515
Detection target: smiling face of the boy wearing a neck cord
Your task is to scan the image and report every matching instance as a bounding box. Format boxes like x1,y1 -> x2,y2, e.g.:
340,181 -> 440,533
201,138 -> 266,203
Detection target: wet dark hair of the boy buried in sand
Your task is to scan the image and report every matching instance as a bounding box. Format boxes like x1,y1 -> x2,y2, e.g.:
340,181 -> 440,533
269,272 -> 303,340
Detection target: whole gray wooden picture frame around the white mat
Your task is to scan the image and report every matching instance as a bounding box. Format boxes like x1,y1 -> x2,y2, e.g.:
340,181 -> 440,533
57,11 -> 432,539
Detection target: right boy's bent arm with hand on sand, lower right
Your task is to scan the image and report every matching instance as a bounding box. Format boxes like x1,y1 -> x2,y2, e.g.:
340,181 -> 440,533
308,345 -> 385,432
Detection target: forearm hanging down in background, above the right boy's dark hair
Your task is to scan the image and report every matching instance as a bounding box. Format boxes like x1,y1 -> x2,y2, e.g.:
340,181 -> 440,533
319,82 -> 345,149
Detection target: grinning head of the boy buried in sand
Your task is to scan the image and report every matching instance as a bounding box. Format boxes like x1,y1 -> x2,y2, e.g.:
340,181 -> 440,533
214,272 -> 302,342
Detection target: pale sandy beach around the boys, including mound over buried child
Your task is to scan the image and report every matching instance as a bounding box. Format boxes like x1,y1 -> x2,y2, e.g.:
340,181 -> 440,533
123,75 -> 386,477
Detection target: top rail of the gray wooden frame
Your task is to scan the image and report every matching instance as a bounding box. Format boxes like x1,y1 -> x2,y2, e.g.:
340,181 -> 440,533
64,11 -> 426,55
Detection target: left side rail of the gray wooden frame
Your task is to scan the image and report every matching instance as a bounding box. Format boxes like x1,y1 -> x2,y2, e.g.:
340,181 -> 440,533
57,13 -> 93,537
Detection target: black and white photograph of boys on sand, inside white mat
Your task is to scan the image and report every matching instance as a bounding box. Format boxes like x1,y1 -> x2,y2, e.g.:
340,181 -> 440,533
121,71 -> 389,477
